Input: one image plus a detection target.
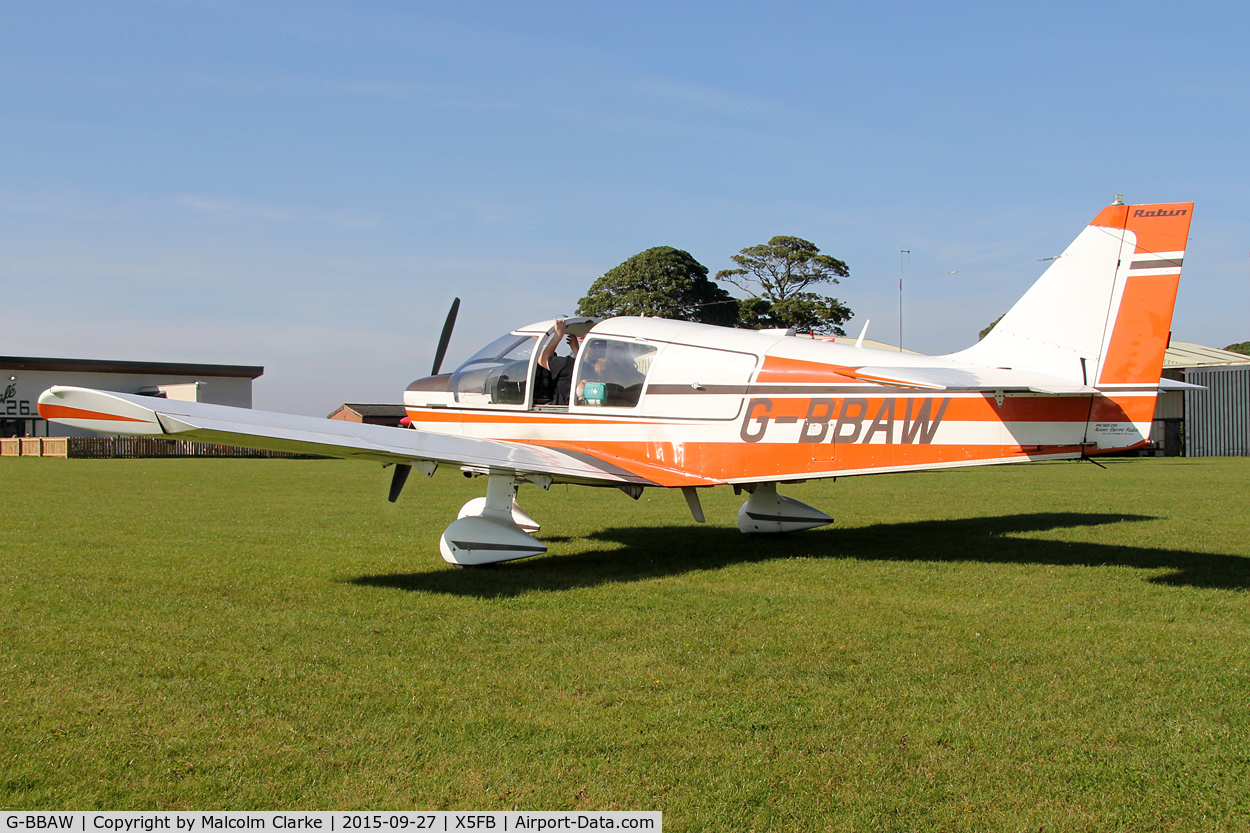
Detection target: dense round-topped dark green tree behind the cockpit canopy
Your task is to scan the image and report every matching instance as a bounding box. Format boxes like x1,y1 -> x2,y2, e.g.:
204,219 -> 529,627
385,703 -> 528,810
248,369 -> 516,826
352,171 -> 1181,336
578,246 -> 738,326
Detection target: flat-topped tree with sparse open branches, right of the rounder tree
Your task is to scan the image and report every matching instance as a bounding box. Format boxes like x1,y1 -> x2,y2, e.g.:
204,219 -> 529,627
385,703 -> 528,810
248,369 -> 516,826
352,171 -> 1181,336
716,236 -> 854,335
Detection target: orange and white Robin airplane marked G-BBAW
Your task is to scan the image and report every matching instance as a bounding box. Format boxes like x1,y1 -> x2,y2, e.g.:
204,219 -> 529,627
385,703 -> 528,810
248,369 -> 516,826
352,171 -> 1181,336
39,203 -> 1193,565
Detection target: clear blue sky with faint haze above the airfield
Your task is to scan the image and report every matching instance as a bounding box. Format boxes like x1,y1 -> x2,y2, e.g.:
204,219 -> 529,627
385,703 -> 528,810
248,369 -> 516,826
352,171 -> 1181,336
0,0 -> 1250,415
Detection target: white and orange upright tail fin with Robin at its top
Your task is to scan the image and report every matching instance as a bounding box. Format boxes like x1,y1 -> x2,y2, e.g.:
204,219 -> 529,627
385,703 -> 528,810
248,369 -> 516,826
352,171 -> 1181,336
951,203 -> 1194,388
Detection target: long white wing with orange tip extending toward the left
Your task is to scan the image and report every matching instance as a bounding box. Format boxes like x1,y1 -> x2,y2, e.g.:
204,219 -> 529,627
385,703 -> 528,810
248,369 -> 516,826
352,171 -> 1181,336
39,385 -> 654,485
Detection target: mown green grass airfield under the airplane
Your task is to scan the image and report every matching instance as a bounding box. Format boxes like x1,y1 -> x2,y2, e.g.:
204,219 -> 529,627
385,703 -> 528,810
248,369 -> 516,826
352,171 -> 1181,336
0,458 -> 1250,832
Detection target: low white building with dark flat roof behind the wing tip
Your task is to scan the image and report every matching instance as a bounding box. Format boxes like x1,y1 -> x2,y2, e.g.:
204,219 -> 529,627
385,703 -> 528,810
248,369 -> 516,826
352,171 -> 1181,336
0,355 -> 265,437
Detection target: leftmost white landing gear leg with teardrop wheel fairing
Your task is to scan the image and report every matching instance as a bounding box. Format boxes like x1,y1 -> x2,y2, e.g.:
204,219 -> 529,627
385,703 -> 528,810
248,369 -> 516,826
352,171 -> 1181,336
439,472 -> 546,567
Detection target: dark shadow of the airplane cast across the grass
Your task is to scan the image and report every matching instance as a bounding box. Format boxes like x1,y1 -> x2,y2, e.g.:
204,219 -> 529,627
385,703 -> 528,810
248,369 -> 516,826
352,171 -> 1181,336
351,513 -> 1250,598
